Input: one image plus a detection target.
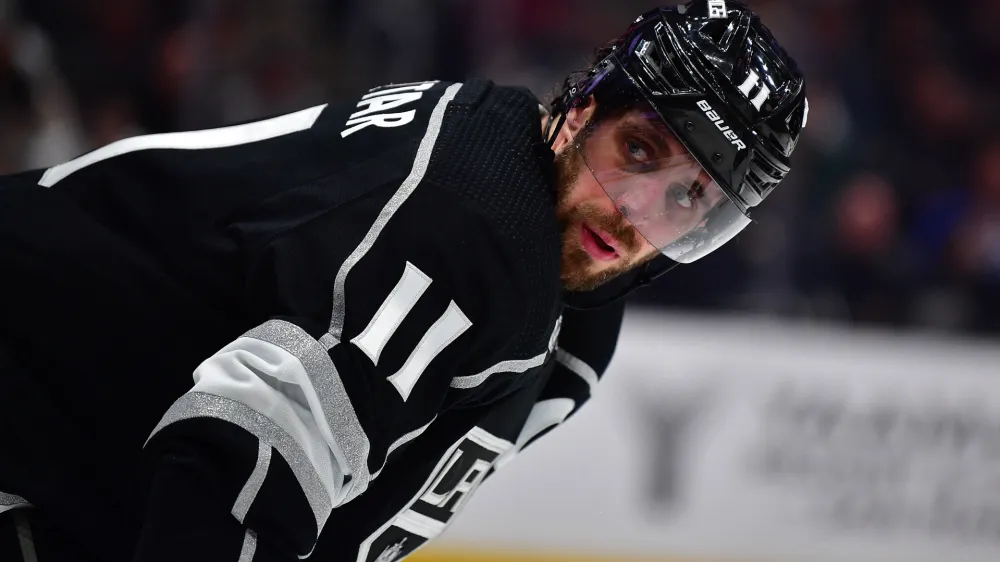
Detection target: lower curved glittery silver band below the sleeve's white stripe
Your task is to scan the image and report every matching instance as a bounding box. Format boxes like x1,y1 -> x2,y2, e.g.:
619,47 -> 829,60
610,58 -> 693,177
147,392 -> 333,529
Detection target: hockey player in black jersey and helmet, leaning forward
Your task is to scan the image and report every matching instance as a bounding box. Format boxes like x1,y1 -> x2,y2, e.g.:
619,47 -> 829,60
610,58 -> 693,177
0,0 -> 808,562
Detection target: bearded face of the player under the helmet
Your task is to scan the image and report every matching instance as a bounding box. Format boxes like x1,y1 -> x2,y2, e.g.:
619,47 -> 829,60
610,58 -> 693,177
554,103 -> 724,291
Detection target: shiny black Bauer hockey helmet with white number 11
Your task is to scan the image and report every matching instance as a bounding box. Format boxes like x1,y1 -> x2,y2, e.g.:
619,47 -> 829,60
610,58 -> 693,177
549,0 -> 809,308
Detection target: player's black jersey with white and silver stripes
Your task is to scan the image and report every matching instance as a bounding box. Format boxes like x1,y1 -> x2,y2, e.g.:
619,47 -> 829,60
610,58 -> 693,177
0,82 -> 617,562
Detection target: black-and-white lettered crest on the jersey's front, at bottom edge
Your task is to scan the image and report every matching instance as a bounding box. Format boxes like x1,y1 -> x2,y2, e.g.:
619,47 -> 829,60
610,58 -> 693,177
357,427 -> 514,562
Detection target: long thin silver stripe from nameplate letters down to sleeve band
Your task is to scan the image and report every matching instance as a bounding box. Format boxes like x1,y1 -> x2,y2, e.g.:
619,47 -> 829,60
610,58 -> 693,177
330,84 -> 462,342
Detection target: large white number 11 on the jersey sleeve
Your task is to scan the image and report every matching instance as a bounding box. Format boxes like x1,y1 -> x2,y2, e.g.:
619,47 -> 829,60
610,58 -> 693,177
351,262 -> 472,401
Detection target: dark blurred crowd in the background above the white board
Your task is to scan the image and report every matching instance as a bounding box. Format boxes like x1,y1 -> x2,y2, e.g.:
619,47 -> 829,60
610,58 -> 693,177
0,0 -> 1000,334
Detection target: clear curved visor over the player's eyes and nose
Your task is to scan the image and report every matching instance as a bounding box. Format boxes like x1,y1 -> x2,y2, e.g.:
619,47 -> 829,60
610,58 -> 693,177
579,109 -> 750,263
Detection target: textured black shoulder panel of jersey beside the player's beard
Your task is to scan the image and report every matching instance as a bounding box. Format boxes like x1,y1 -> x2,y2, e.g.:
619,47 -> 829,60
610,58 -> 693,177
427,81 -> 562,355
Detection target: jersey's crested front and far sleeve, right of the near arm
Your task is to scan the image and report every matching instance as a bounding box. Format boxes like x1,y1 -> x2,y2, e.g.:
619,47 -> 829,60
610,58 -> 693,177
314,303 -> 624,562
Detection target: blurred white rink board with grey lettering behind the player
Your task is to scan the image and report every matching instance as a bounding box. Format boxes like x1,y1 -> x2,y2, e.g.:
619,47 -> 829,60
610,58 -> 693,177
424,312 -> 1000,562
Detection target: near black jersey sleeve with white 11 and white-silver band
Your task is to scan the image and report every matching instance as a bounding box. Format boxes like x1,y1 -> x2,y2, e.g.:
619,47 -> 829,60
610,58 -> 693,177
137,182 -> 525,562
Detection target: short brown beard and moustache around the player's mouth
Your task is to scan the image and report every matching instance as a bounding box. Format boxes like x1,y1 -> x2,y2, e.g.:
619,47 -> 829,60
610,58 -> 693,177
555,142 -> 641,291
